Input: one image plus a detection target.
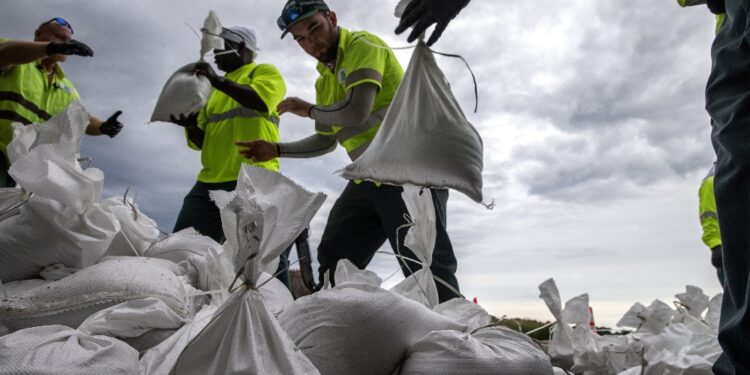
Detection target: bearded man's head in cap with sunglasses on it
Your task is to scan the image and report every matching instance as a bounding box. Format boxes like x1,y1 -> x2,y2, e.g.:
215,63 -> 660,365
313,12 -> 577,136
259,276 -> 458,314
276,0 -> 339,63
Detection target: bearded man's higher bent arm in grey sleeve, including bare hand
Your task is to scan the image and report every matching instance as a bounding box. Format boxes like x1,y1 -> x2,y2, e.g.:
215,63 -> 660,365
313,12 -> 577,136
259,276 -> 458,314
278,83 -> 378,128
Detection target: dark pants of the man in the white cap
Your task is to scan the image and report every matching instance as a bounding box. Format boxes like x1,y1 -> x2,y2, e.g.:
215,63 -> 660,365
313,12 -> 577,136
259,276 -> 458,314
172,181 -> 292,290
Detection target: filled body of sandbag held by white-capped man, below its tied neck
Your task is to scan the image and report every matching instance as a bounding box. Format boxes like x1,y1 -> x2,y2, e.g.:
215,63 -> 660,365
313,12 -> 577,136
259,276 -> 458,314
151,63 -> 212,122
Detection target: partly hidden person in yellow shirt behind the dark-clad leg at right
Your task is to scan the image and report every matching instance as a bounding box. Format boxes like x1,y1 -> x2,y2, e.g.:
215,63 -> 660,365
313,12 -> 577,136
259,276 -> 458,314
698,163 -> 724,286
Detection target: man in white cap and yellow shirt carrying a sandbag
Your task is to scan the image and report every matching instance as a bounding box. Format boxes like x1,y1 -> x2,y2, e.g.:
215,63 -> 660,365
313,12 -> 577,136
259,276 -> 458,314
172,26 -> 294,283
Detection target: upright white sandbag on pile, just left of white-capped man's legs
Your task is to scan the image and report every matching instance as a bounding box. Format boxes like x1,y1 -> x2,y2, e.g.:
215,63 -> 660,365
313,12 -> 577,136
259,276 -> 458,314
99,197 -> 159,256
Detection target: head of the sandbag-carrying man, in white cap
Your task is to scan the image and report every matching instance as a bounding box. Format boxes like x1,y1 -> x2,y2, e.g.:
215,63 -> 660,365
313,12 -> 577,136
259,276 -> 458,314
214,26 -> 260,72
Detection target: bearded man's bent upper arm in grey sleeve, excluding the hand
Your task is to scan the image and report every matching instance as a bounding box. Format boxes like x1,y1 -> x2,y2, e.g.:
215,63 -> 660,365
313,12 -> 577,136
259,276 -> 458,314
310,83 -> 378,127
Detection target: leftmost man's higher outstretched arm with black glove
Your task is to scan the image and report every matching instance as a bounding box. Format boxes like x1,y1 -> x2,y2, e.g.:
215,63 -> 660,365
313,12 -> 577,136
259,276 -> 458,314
0,39 -> 94,70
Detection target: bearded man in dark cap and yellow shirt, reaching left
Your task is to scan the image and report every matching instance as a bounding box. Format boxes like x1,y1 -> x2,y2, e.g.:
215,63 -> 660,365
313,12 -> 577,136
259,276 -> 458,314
239,0 -> 458,301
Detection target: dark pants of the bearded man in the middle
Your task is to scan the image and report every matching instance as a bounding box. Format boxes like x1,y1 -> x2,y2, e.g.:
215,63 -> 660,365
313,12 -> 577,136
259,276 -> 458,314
318,181 -> 458,302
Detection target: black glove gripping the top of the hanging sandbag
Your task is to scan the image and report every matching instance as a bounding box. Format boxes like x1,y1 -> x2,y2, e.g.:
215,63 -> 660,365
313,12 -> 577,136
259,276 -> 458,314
396,0 -> 470,46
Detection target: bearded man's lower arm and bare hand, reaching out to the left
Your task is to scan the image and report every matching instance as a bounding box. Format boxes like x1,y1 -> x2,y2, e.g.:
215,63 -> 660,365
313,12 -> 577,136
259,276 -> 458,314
235,134 -> 336,162
